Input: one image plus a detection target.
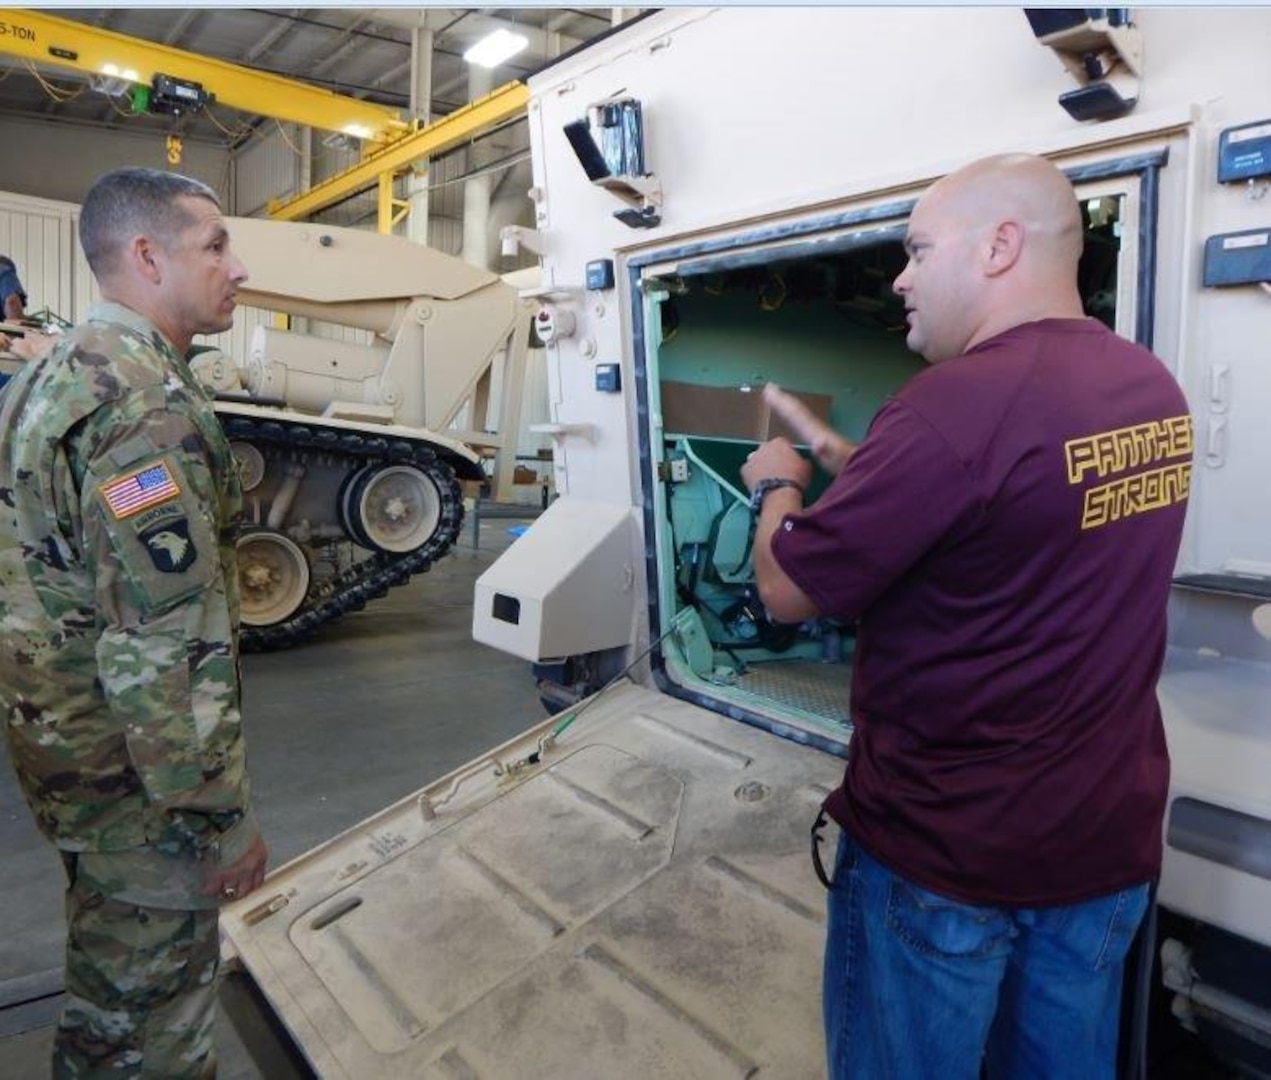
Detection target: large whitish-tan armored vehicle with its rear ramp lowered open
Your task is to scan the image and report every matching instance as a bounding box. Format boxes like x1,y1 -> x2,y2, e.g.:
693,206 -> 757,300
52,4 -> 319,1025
225,8 -> 1271,1077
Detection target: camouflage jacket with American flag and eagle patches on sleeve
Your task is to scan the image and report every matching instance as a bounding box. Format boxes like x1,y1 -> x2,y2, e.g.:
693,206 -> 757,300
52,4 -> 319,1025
0,304 -> 258,902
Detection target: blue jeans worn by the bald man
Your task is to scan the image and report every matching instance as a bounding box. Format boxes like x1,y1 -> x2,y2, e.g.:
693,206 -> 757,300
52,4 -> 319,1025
824,832 -> 1148,1080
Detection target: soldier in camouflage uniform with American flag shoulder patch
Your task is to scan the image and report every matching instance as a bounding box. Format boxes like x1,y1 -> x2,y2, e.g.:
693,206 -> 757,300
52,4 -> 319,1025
0,169 -> 266,1076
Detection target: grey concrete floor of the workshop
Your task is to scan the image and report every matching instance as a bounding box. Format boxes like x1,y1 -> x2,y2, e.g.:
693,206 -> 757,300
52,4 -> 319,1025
0,516 -> 545,1080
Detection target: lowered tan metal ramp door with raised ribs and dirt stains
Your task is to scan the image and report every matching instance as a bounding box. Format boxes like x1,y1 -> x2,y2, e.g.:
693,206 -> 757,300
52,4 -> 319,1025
222,686 -> 843,1080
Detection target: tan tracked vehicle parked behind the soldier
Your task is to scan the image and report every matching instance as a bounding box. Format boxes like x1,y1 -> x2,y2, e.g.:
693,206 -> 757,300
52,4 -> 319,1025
205,219 -> 531,649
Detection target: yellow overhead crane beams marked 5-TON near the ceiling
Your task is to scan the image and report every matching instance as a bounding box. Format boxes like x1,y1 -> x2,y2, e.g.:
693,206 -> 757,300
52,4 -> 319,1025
0,9 -> 529,233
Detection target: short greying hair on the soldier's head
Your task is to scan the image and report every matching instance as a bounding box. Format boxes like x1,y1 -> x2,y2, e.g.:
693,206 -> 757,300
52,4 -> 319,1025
79,169 -> 221,280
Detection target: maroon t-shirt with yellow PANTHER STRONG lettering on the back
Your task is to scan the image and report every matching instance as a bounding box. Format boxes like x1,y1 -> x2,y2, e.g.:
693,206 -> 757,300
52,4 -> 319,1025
773,319 -> 1192,906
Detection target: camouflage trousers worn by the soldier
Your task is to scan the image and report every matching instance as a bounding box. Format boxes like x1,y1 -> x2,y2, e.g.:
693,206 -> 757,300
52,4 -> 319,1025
53,854 -> 220,1080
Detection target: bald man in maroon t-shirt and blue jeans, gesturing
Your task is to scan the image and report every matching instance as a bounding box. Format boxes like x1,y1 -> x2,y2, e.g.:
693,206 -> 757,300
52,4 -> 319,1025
742,155 -> 1192,1080
